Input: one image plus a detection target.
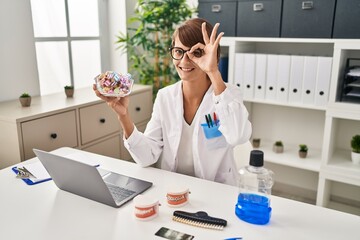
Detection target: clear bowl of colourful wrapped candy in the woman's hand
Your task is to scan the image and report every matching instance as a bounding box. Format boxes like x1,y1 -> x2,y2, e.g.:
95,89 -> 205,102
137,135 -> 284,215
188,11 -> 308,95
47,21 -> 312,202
95,71 -> 134,97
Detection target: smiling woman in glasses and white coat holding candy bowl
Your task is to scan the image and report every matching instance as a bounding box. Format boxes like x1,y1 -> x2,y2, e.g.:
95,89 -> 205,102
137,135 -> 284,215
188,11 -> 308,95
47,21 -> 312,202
94,18 -> 252,185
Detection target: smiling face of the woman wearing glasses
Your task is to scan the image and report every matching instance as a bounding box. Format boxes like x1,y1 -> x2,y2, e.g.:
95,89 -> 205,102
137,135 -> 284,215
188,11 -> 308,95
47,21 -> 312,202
173,37 -> 206,81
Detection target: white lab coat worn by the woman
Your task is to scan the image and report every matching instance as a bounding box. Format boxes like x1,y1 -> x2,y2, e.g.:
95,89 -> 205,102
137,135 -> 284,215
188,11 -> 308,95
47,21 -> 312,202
124,81 -> 252,185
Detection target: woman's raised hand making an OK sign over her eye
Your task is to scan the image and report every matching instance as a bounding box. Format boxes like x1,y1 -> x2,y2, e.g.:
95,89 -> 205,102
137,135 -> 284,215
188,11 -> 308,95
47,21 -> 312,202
186,22 -> 224,74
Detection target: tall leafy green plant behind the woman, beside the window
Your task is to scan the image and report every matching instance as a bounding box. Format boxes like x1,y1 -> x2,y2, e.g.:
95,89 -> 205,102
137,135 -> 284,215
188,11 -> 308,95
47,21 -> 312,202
116,0 -> 196,95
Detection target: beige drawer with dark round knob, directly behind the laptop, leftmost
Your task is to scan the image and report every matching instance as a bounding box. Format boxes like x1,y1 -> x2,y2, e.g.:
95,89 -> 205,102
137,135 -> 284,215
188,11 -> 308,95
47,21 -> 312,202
21,111 -> 78,159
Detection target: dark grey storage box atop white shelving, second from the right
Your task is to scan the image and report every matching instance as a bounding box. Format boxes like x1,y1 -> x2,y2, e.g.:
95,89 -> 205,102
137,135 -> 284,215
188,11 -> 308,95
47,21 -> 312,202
281,0 -> 335,38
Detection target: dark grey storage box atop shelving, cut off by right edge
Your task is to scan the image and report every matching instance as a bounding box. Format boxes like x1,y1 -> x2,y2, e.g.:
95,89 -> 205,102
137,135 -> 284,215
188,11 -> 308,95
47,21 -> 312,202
333,0 -> 360,38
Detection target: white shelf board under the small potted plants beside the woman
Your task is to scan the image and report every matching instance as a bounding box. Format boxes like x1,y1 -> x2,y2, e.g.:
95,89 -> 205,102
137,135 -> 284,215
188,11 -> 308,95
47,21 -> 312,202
253,140 -> 321,172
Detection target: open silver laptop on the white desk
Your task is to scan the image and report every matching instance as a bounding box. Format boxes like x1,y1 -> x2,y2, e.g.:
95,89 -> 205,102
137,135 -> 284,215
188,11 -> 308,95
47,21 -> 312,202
33,149 -> 152,207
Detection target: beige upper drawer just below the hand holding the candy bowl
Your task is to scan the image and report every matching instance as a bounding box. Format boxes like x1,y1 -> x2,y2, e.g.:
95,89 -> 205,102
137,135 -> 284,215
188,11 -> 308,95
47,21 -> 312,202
79,102 -> 120,144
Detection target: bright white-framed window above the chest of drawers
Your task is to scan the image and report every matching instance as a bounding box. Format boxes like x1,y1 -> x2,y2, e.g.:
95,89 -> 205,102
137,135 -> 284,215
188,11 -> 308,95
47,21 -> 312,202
31,0 -> 109,95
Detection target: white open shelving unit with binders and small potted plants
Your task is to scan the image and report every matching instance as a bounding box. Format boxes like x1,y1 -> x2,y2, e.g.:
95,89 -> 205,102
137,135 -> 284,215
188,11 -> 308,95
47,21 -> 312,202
221,37 -> 360,215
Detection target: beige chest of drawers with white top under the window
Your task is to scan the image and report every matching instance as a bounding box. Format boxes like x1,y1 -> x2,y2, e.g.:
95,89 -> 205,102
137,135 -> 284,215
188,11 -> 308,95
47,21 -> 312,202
0,84 -> 152,169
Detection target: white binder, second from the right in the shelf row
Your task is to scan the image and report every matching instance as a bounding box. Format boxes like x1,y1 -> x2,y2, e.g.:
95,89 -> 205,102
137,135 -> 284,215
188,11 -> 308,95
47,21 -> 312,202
302,56 -> 318,104
